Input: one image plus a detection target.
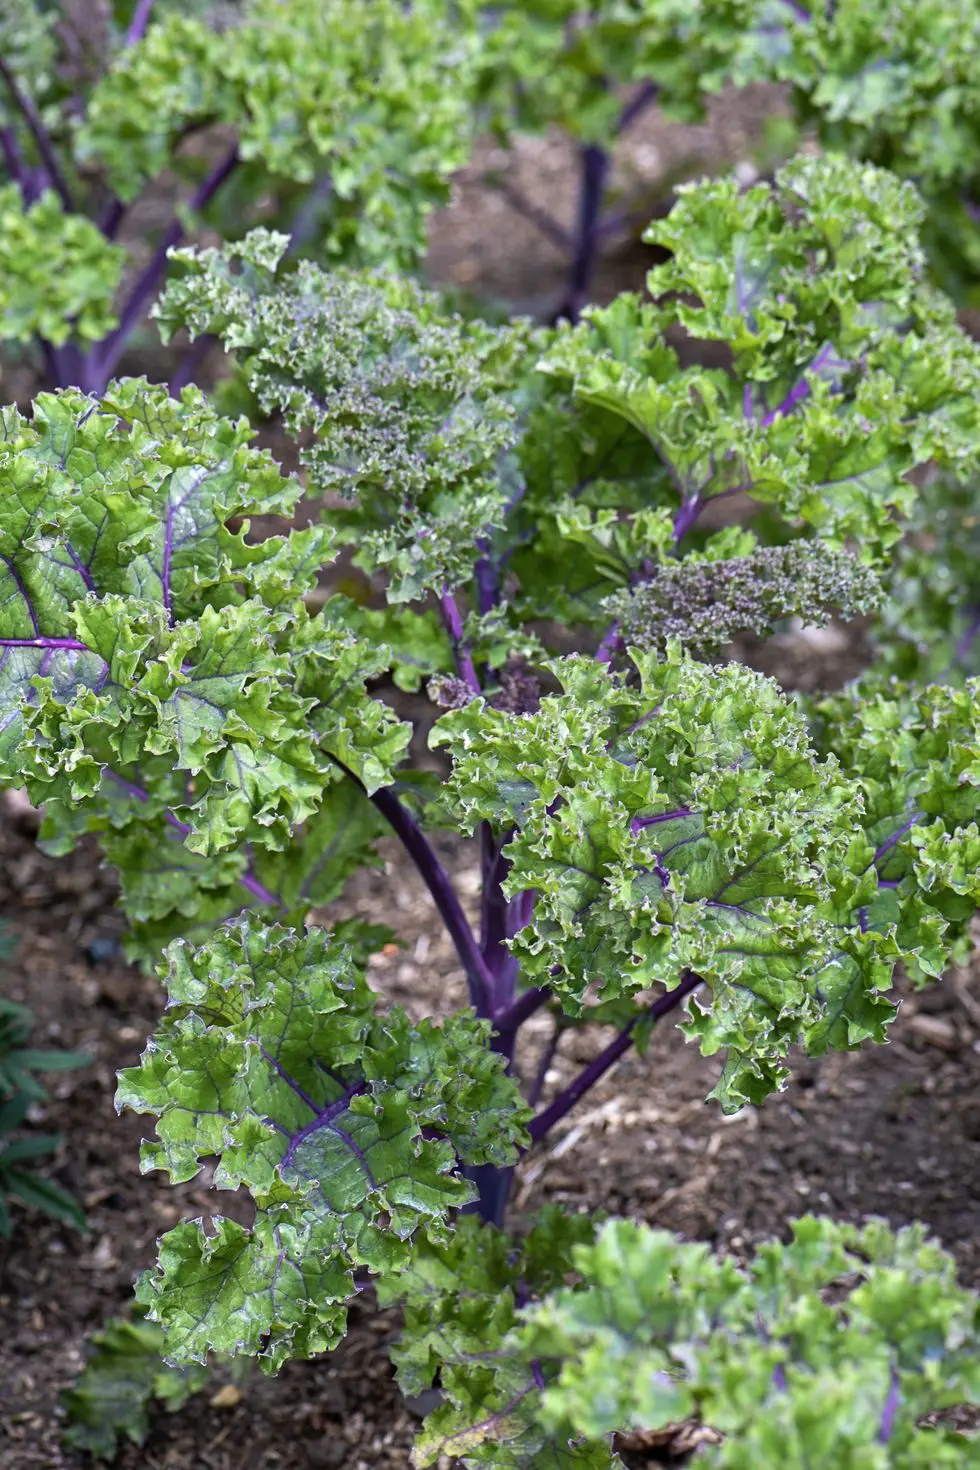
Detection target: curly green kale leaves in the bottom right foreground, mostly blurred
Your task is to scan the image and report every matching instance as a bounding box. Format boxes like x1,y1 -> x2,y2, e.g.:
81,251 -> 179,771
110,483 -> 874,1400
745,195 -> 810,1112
383,1207 -> 980,1470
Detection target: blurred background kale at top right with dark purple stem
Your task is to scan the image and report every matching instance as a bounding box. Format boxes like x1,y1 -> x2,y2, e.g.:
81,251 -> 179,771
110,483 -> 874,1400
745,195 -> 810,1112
476,0 -> 980,320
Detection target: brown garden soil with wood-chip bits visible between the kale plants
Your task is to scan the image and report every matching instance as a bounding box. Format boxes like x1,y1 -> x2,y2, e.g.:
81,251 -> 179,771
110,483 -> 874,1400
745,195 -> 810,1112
0,98 -> 980,1470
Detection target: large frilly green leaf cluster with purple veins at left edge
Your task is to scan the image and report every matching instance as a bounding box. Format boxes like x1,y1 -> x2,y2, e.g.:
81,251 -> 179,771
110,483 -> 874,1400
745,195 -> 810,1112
0,381 -> 408,957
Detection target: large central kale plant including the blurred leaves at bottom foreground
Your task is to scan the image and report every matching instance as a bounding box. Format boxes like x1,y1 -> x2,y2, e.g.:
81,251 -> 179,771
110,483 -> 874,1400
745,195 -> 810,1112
0,157 -> 980,1470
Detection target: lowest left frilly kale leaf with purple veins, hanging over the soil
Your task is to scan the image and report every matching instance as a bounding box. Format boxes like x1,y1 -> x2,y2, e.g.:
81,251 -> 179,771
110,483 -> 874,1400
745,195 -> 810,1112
116,920 -> 529,1372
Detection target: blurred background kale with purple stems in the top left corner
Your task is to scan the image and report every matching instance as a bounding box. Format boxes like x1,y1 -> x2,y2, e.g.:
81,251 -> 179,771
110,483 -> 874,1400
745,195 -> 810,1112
0,0 -> 473,392
